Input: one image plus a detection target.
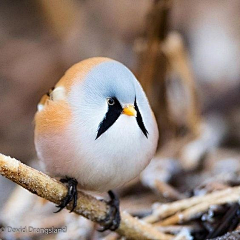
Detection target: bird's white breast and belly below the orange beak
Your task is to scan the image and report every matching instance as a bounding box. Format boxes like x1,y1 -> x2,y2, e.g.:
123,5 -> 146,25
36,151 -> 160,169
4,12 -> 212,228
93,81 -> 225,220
71,112 -> 155,191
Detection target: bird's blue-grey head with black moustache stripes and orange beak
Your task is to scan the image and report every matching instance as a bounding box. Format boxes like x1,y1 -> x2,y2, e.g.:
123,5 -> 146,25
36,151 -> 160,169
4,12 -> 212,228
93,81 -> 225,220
63,58 -> 148,139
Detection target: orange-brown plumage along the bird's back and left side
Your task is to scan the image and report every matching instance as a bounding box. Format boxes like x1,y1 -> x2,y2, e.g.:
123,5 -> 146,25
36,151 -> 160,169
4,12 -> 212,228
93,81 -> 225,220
35,57 -> 111,135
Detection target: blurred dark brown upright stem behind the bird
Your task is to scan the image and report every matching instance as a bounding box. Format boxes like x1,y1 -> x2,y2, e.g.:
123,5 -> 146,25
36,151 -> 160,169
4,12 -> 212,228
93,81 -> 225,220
138,0 -> 175,146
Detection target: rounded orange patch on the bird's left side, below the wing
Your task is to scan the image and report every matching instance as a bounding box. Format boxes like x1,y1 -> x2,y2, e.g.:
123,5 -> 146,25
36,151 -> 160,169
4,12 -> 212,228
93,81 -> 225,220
35,100 -> 72,135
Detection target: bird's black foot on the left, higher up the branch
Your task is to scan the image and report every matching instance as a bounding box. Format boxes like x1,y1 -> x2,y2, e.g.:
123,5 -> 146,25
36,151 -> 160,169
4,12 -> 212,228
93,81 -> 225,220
54,177 -> 78,213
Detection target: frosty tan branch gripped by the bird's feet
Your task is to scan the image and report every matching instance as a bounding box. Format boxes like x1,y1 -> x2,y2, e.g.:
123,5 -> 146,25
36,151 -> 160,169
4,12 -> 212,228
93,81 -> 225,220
0,154 -> 172,240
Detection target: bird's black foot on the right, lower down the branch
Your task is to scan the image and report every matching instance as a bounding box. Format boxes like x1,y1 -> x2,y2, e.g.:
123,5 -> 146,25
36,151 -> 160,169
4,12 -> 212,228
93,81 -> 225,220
98,191 -> 121,232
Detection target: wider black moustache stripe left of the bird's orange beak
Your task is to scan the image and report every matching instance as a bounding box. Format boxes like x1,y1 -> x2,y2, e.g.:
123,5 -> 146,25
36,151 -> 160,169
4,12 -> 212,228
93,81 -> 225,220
95,98 -> 123,140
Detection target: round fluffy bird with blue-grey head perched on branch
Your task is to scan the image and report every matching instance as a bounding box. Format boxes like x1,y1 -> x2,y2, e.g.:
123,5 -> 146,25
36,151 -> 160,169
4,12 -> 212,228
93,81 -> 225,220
34,57 -> 159,230
